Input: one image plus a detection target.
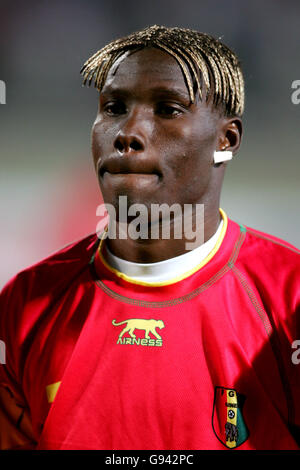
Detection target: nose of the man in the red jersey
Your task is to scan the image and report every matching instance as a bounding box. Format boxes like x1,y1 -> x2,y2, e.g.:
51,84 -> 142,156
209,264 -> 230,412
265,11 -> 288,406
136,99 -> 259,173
114,107 -> 145,154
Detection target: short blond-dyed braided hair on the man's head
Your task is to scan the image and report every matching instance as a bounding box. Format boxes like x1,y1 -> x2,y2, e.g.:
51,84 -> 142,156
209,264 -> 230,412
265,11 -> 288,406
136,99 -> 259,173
80,25 -> 245,116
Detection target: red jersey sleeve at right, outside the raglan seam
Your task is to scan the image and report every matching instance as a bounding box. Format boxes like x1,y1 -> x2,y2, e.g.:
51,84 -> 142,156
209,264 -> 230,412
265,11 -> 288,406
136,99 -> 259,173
244,229 -> 300,446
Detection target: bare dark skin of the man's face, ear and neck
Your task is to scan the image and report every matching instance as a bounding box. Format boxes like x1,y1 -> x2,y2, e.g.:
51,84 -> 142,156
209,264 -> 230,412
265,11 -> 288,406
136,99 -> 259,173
92,48 -> 242,263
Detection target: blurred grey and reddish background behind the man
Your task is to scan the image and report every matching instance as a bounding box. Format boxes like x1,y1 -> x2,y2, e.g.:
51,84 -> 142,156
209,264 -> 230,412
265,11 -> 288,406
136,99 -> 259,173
0,0 -> 300,287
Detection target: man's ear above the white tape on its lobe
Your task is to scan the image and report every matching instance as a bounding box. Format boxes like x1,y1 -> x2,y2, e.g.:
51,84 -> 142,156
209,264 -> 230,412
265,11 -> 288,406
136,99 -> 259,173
216,117 -> 243,155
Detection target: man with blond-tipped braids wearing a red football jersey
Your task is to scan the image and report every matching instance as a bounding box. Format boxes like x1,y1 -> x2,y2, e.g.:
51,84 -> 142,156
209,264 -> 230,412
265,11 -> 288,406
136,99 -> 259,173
0,26 -> 300,449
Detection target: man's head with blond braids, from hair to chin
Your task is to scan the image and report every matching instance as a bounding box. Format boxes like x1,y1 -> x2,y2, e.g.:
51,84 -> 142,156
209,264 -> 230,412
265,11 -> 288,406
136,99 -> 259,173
82,26 -> 244,221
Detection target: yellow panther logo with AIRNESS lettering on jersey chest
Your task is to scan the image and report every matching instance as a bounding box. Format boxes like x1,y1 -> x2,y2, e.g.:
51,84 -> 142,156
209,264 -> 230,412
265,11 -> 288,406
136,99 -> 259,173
112,318 -> 165,346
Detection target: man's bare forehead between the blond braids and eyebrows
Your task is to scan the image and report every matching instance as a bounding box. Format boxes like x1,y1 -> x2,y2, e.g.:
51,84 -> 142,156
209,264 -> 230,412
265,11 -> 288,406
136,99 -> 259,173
102,48 -> 188,95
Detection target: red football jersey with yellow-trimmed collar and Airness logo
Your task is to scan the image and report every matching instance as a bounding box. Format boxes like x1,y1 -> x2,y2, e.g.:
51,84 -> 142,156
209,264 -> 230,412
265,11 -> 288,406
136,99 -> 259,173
0,212 -> 300,450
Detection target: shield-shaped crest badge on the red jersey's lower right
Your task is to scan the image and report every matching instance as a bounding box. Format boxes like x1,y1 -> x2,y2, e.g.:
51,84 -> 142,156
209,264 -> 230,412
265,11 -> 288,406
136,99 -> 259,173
212,387 -> 249,449
